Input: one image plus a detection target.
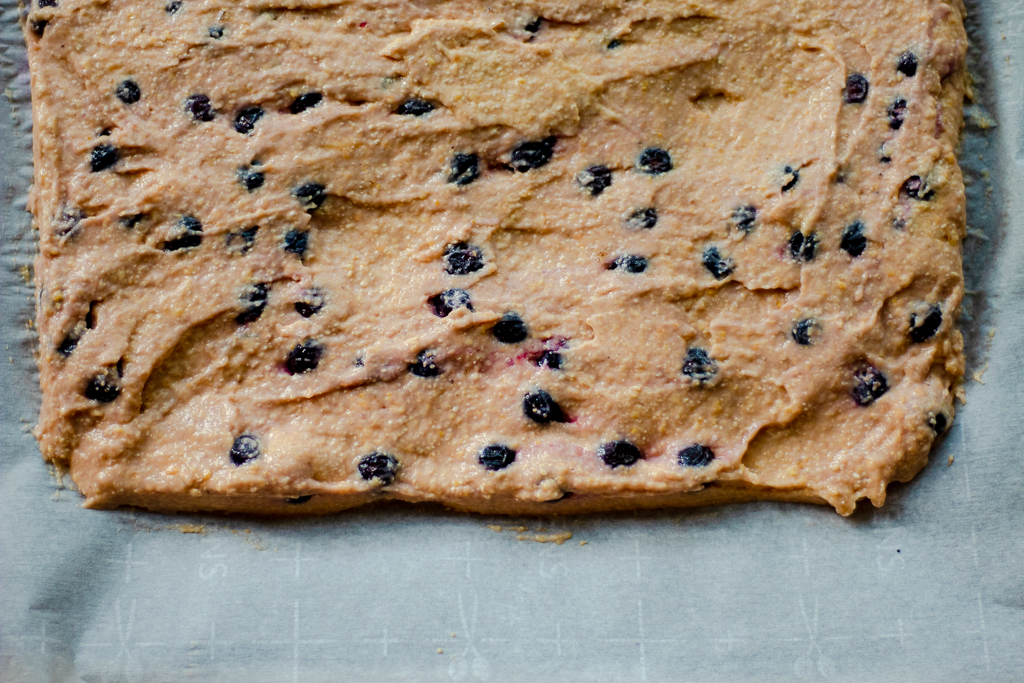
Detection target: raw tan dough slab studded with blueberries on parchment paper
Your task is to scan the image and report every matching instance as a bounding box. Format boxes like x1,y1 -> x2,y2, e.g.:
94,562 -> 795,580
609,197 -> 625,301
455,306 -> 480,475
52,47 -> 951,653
25,0 -> 967,514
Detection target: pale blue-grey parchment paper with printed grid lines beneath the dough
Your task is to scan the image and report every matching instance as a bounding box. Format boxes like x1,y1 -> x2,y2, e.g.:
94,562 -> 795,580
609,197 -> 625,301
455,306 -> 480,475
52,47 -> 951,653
0,0 -> 1024,683
